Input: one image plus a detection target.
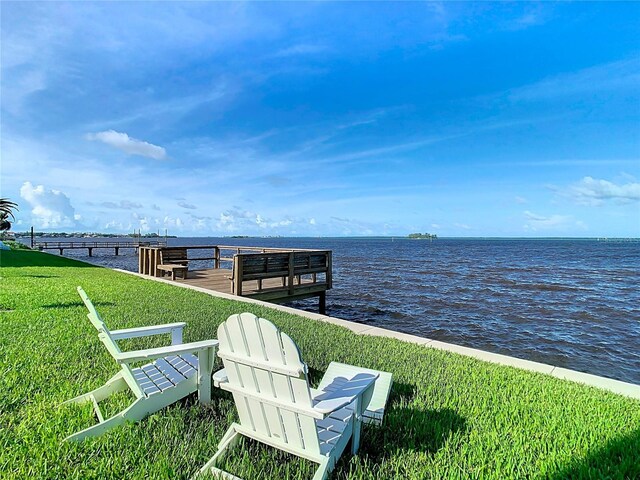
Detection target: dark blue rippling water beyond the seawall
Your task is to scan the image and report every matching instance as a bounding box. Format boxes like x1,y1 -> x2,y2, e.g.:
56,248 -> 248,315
28,238 -> 640,384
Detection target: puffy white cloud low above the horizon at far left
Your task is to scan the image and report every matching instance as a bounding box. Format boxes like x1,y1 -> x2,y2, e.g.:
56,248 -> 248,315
20,182 -> 80,228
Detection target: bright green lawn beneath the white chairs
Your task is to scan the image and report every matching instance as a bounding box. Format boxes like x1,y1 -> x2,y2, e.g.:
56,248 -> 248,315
0,250 -> 640,480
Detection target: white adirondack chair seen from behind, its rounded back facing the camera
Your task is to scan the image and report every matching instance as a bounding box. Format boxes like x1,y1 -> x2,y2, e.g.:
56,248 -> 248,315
196,313 -> 391,480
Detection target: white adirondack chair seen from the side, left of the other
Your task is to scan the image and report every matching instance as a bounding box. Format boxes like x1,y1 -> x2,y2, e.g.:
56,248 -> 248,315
64,287 -> 218,441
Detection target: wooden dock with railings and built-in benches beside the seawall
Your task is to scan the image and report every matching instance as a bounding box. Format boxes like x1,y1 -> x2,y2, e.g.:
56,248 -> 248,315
138,245 -> 332,313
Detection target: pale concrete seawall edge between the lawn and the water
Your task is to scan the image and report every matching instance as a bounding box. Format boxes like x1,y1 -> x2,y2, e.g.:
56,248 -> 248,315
112,268 -> 640,399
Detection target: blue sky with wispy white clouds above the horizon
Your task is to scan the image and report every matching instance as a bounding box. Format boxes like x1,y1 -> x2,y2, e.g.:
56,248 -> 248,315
0,2 -> 640,237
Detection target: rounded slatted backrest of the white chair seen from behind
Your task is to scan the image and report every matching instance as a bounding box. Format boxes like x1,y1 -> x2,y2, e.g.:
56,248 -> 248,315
218,313 -> 320,454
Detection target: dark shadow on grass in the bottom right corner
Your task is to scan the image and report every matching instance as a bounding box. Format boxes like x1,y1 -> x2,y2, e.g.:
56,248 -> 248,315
548,427 -> 640,480
